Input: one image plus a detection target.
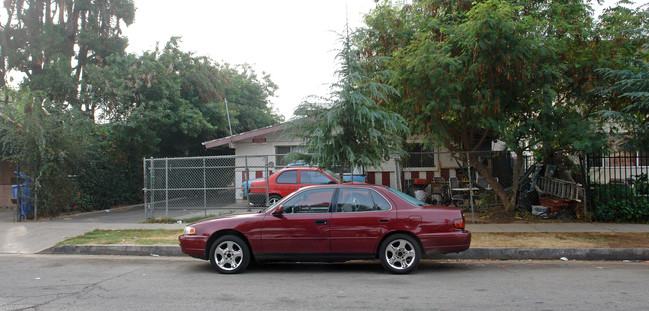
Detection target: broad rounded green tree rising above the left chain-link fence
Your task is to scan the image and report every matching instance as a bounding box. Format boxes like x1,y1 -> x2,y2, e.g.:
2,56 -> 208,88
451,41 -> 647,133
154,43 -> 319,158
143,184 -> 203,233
90,38 -> 282,160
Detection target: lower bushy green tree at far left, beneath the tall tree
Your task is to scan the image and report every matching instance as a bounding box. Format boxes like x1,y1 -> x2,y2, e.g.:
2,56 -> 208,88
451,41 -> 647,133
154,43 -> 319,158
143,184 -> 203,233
0,89 -> 96,216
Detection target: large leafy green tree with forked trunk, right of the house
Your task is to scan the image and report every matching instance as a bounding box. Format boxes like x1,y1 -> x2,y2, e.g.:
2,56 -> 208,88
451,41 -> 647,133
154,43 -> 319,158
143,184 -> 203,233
364,0 -> 644,210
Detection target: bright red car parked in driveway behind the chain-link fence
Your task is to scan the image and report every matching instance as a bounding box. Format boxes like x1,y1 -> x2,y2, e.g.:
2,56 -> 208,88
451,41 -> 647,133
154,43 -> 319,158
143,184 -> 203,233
248,167 -> 339,205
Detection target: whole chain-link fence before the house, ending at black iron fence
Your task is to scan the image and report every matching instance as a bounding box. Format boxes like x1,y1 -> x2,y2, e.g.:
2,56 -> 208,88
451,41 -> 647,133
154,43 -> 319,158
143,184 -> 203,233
144,152 -> 530,221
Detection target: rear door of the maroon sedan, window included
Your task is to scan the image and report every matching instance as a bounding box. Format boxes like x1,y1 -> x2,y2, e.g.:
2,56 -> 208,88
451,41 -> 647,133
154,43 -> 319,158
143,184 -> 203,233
329,187 -> 396,255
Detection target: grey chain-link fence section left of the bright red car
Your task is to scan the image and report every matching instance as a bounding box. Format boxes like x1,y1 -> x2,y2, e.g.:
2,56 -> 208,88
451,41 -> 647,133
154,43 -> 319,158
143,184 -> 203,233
143,155 -> 308,219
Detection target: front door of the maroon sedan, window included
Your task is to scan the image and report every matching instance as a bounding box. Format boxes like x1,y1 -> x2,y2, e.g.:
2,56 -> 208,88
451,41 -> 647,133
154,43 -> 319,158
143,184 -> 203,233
262,187 -> 335,256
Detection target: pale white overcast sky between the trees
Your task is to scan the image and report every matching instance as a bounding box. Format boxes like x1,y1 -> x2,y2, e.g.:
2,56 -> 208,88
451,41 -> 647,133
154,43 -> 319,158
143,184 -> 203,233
124,0 -> 375,120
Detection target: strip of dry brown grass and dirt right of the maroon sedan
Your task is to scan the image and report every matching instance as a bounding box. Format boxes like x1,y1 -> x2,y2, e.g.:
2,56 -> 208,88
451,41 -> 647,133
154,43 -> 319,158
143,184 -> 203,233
471,232 -> 649,248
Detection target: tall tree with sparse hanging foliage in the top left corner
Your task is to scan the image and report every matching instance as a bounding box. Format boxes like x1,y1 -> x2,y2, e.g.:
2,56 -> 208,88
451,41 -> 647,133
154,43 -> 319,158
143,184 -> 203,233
0,0 -> 135,118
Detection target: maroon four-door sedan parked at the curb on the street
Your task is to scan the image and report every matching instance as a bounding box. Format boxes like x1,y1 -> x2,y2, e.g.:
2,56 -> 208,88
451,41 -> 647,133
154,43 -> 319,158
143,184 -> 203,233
178,184 -> 471,273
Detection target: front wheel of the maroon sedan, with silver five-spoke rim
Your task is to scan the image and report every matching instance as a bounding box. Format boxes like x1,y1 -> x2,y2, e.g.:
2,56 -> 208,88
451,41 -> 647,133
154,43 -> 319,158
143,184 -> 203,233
210,235 -> 252,274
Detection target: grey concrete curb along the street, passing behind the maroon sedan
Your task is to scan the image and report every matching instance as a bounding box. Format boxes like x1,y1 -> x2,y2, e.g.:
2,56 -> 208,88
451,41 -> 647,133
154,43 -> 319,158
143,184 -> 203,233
40,244 -> 649,261
